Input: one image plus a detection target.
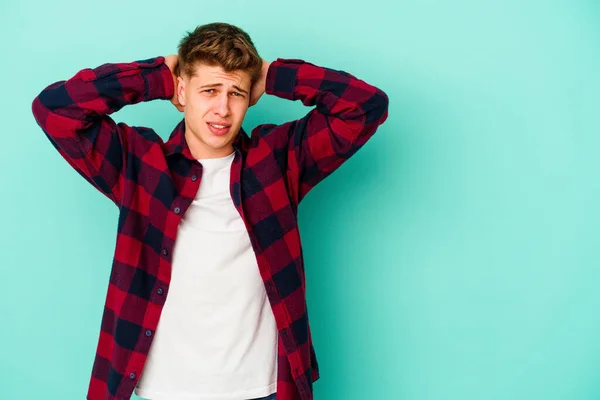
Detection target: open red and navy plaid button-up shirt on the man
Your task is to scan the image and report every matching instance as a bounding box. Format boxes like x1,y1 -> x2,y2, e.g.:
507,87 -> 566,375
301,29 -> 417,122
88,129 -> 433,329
33,57 -> 388,400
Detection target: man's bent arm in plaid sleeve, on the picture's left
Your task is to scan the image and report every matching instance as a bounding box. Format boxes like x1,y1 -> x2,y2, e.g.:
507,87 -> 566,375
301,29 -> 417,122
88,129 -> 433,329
32,57 -> 174,206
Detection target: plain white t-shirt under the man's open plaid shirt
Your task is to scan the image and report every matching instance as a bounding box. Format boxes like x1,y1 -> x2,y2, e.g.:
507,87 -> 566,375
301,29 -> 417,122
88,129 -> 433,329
135,152 -> 277,400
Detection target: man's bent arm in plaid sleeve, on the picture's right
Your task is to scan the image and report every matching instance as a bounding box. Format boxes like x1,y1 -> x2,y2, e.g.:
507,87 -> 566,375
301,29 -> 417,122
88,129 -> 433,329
258,58 -> 388,204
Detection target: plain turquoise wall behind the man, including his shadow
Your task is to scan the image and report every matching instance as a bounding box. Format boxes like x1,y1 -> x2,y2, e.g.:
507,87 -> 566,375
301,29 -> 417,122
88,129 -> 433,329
0,0 -> 600,400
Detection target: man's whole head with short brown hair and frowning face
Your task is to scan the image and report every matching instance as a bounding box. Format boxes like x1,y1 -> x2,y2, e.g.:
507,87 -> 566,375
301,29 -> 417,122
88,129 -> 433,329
176,23 -> 262,158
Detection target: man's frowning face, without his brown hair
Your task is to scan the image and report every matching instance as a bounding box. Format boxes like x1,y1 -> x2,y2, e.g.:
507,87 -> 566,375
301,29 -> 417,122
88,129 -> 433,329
177,64 -> 251,159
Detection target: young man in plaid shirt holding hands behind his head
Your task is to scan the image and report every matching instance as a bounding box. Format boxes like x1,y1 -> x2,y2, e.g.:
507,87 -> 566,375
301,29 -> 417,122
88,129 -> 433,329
33,23 -> 388,400
